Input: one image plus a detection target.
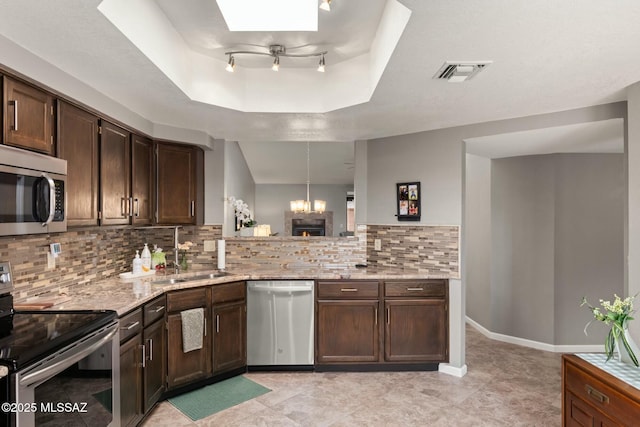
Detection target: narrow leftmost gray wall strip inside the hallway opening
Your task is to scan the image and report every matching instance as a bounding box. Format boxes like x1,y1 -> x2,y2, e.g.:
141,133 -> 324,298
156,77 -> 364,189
463,154 -> 491,328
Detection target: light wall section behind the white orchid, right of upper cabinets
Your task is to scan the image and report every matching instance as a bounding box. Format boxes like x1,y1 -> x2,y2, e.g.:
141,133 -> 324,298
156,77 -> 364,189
222,141 -> 256,237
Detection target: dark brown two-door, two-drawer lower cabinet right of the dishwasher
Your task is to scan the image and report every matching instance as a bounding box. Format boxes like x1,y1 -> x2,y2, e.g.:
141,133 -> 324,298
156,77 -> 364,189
316,280 -> 449,368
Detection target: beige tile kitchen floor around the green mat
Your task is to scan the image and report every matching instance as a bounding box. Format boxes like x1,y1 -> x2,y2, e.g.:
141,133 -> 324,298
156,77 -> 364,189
143,327 -> 561,427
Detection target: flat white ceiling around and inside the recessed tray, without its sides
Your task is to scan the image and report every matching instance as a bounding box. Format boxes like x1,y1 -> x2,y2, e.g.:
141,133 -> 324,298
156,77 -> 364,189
0,0 -> 640,181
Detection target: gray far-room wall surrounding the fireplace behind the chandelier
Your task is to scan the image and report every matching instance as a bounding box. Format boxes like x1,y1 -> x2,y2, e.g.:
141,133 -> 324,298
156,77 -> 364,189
255,184 -> 353,236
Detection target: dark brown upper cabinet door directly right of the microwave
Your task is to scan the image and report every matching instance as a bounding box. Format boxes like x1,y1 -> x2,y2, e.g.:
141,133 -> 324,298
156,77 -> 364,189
58,102 -> 99,226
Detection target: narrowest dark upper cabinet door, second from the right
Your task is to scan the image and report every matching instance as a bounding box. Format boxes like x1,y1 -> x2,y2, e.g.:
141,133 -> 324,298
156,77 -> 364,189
131,135 -> 155,225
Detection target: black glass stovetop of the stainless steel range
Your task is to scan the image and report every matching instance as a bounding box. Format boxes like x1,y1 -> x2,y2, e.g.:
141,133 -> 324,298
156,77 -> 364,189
0,310 -> 117,371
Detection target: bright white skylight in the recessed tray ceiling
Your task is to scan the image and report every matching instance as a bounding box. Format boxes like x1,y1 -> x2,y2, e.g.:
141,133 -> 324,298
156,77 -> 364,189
216,0 -> 318,31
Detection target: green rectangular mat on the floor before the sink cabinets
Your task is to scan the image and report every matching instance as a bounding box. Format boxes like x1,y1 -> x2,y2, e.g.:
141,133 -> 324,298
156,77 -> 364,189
169,375 -> 271,421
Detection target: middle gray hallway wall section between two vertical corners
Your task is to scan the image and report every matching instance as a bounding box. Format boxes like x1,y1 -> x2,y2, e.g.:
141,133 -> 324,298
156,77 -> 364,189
488,156 -> 554,343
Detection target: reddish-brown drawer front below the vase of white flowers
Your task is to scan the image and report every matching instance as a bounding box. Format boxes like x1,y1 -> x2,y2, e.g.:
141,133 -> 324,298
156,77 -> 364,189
564,363 -> 640,425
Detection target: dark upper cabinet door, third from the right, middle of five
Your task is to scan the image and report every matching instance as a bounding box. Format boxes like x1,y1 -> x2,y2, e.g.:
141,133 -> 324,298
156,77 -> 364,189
100,121 -> 132,225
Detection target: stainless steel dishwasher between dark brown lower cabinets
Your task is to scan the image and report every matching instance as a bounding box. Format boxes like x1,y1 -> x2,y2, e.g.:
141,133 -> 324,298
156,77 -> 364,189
247,280 -> 314,370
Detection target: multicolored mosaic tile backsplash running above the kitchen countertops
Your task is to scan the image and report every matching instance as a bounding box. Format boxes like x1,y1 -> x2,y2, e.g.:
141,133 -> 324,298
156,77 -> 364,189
0,225 -> 459,303
